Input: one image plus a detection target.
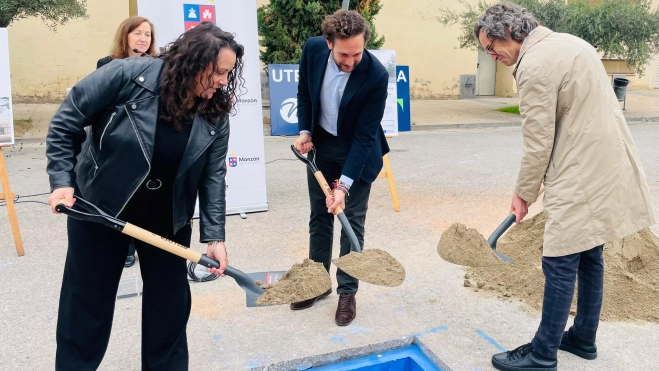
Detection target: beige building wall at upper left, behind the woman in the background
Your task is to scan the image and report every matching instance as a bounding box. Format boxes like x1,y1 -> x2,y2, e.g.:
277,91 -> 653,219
8,0 -> 128,103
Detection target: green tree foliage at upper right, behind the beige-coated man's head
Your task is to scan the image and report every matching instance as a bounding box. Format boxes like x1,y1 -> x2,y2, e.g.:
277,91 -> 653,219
437,0 -> 659,73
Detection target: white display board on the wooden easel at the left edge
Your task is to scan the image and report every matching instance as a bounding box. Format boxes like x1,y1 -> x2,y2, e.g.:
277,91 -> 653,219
0,28 -> 14,146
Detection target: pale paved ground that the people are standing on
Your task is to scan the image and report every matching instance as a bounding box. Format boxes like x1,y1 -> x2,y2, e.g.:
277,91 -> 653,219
0,123 -> 659,371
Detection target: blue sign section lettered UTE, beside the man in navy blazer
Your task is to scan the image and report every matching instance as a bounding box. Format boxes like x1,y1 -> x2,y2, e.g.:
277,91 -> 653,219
268,64 -> 300,135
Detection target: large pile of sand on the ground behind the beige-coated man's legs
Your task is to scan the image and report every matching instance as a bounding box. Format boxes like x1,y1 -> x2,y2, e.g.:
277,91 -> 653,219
465,212 -> 659,322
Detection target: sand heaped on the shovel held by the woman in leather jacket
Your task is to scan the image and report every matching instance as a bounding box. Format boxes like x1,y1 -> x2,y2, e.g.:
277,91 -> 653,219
256,259 -> 332,305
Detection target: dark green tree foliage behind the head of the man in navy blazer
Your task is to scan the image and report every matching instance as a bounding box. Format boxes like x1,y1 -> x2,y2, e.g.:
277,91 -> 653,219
256,0 -> 384,72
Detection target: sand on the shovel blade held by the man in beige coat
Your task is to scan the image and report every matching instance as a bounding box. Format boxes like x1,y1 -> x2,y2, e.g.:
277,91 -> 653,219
437,223 -> 504,267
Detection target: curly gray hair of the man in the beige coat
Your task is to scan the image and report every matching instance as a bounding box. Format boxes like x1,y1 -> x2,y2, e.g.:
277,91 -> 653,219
474,3 -> 538,43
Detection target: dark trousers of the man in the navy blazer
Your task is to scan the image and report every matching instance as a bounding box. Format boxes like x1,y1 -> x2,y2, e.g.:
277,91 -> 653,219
307,127 -> 371,294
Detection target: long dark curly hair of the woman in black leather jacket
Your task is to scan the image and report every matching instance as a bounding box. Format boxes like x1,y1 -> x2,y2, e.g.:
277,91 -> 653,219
160,22 -> 245,130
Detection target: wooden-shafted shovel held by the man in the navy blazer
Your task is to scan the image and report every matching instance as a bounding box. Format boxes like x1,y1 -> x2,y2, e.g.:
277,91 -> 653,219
291,145 -> 405,286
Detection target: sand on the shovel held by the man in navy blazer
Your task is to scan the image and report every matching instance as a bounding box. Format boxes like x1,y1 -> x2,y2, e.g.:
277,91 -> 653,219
334,249 -> 405,287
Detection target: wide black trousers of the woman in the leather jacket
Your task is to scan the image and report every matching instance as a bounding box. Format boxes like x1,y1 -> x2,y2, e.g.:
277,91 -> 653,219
55,205 -> 192,371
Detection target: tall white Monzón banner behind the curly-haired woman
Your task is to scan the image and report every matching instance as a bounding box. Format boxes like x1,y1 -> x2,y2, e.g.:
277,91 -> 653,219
137,0 -> 268,217
